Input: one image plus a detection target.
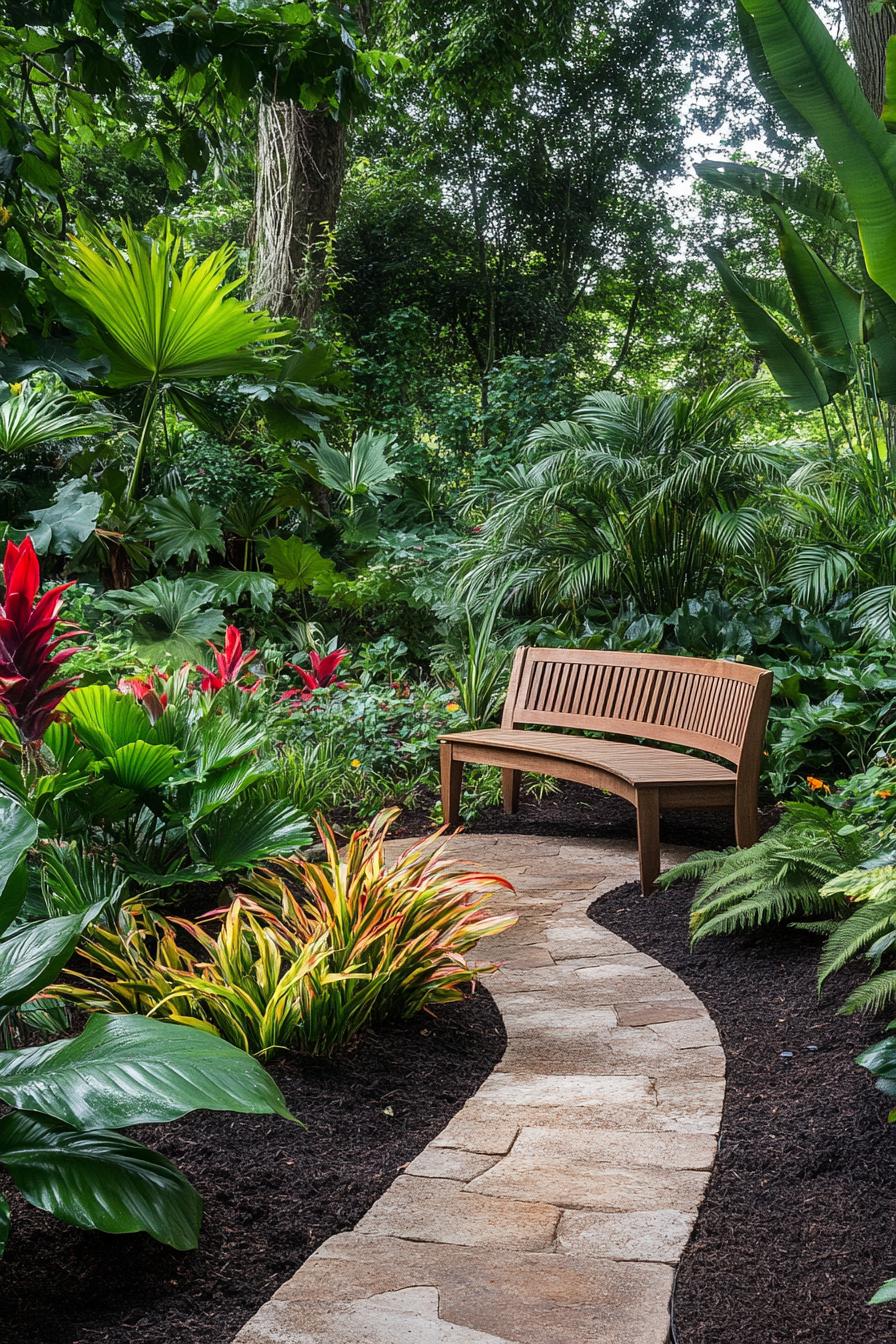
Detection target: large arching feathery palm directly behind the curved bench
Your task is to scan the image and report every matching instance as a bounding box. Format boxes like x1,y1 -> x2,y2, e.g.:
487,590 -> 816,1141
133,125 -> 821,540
458,382 -> 786,618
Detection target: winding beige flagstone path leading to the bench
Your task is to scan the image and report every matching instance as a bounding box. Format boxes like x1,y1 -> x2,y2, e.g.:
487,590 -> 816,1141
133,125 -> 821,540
236,836 -> 725,1344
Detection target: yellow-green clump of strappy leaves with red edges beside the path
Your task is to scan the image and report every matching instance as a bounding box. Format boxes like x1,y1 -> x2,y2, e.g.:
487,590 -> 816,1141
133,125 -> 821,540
55,810 -> 516,1058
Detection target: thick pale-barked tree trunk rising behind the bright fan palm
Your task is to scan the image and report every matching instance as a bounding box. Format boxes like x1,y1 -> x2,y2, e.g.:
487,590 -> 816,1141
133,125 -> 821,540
251,102 -> 345,327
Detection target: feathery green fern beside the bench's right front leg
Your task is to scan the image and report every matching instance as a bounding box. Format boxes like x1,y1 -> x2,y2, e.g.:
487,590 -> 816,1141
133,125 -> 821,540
661,802 -> 872,942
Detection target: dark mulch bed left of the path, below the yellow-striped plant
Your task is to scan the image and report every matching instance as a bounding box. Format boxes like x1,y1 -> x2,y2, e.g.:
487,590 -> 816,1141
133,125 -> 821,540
0,991 -> 505,1344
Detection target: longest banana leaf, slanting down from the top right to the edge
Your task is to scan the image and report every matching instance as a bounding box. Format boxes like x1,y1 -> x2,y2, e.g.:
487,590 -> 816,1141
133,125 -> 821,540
742,0 -> 896,298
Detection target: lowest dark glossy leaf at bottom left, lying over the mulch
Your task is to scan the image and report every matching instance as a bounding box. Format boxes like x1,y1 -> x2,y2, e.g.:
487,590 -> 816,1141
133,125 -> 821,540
0,1111 -> 203,1250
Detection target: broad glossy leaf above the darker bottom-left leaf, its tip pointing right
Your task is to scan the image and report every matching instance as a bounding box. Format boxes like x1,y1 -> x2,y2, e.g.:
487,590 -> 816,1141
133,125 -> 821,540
0,1015 -> 294,1129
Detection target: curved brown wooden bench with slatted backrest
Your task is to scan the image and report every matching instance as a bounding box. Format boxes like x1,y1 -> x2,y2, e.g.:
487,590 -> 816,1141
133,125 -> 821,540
439,648 -> 772,894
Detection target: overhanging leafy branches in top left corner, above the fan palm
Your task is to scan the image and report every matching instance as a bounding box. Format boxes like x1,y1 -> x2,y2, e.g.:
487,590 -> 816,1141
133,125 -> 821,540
0,0 -> 378,379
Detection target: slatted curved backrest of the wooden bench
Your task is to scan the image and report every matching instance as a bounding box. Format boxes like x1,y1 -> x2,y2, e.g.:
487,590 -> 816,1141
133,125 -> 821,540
501,648 -> 772,767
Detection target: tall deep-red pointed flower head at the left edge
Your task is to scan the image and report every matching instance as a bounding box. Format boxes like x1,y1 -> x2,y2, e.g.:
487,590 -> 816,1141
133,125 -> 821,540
0,536 -> 82,742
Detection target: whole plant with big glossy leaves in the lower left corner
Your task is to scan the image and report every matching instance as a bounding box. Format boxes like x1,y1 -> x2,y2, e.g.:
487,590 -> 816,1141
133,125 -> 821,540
0,802 -> 293,1255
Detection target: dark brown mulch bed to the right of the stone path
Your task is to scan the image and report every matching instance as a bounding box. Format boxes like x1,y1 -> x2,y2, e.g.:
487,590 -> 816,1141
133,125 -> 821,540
590,883 -> 896,1344
